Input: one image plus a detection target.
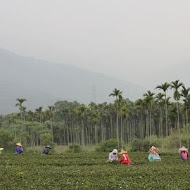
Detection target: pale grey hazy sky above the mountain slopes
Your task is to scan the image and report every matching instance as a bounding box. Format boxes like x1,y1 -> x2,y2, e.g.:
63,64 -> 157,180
0,0 -> 190,86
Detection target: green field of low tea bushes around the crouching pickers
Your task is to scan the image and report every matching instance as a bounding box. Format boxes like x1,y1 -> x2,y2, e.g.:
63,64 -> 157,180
0,153 -> 190,190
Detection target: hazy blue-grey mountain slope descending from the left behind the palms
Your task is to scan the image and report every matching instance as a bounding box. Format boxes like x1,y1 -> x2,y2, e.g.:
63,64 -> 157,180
0,49 -> 145,114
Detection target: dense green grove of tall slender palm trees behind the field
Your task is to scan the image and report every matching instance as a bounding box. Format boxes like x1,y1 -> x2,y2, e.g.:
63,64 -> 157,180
0,80 -> 190,146
